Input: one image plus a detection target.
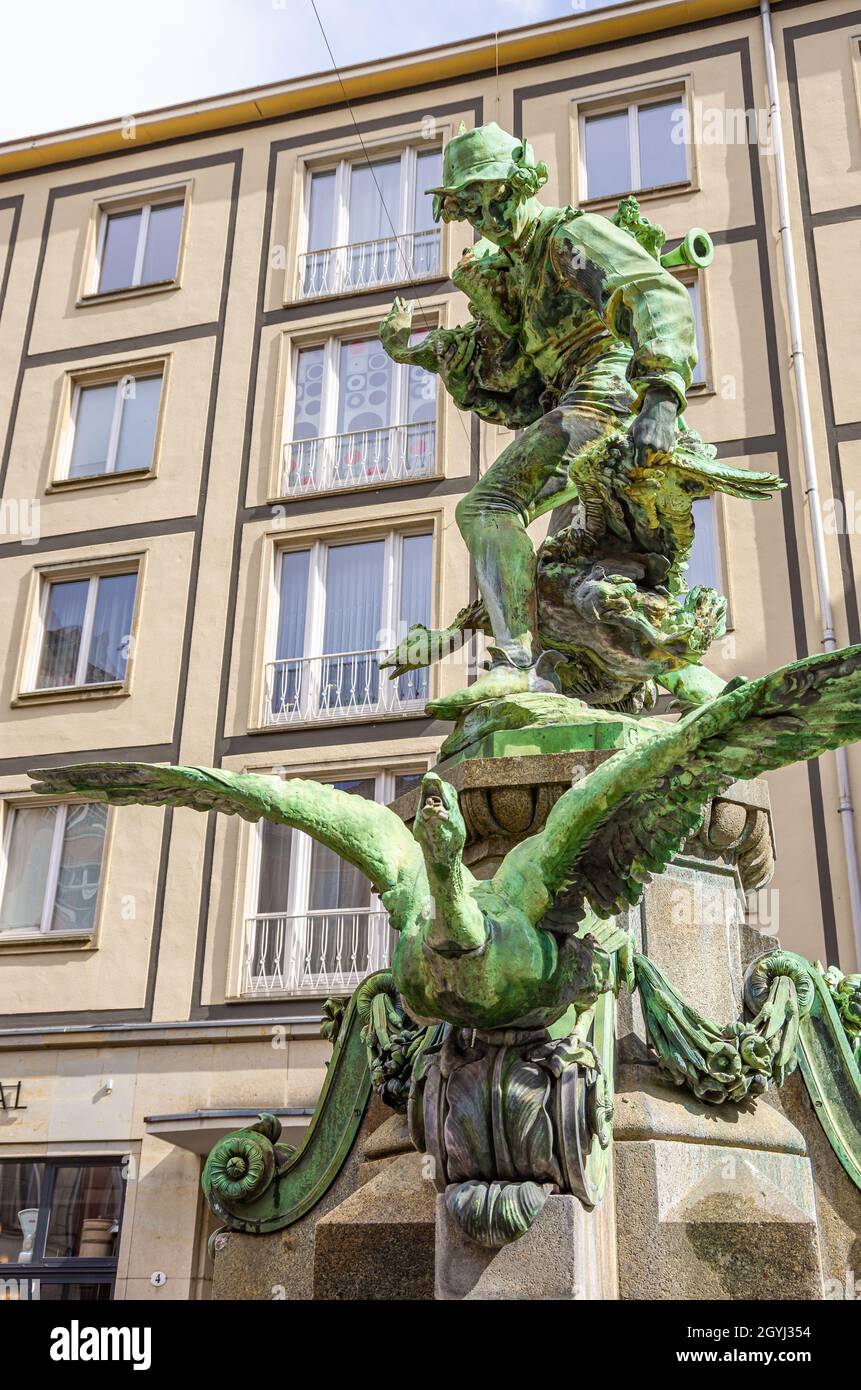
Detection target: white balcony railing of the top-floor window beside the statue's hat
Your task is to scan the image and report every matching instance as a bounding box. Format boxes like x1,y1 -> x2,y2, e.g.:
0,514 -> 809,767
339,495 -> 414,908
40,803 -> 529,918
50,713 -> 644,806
299,227 -> 440,299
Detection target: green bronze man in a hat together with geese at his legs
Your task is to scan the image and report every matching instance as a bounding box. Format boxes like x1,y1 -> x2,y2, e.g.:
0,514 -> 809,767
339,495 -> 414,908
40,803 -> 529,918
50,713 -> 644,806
380,122 -> 782,719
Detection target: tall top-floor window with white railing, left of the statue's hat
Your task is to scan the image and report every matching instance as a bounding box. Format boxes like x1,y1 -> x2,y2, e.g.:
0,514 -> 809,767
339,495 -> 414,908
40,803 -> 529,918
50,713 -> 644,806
299,147 -> 442,299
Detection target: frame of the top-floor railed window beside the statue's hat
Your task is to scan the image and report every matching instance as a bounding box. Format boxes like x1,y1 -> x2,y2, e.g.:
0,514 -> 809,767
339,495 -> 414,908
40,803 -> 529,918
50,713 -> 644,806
292,141 -> 445,303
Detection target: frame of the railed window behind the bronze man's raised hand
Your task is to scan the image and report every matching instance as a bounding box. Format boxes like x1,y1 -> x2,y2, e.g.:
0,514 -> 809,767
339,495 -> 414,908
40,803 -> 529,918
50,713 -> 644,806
268,322 -> 446,502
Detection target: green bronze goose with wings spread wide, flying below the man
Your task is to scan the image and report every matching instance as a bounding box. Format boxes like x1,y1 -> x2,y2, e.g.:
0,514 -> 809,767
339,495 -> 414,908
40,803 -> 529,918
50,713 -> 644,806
33,646 -> 861,1030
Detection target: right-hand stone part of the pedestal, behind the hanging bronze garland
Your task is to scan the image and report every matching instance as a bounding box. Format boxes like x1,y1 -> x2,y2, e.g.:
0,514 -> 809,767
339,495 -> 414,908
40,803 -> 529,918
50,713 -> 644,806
615,783 -> 823,1300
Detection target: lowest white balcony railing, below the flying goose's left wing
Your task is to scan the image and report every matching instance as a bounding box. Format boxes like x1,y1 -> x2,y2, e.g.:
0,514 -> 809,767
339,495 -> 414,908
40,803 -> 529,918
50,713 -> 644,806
242,908 -> 395,994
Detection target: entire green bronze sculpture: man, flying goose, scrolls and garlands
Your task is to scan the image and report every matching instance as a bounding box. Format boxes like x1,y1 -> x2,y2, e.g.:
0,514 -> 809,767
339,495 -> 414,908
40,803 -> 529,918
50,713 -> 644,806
26,124 -> 861,1247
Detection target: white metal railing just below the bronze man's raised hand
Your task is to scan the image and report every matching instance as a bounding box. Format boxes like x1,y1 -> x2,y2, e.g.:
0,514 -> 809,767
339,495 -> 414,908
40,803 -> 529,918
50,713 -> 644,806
281,420 -> 437,496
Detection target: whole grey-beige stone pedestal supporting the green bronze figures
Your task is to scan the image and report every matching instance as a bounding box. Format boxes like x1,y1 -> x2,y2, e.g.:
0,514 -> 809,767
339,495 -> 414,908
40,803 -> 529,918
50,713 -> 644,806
398,756 -> 823,1300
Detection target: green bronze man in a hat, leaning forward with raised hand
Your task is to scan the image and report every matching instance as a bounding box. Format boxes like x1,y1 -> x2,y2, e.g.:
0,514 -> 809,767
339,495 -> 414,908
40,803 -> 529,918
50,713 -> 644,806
380,122 -> 703,714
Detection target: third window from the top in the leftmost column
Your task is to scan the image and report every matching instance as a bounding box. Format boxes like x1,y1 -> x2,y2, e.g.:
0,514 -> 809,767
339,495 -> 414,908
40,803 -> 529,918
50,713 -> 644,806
33,570 -> 138,691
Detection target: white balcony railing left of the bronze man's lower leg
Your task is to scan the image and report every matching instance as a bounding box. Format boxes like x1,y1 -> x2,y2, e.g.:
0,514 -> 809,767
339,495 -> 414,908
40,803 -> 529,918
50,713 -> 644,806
266,651 -> 428,724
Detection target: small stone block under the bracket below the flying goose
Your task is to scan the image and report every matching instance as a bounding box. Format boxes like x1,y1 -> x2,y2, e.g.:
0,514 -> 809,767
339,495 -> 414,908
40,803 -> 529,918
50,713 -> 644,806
435,1194 -> 616,1301
